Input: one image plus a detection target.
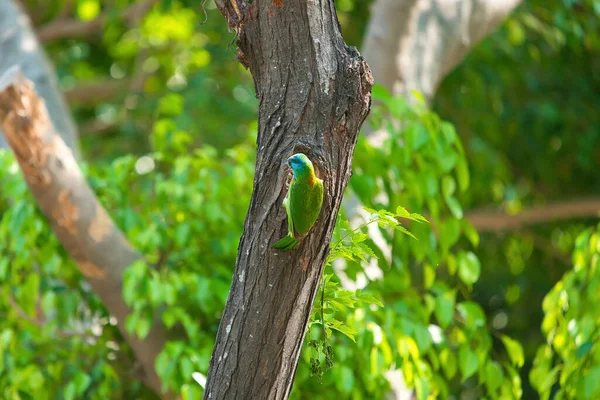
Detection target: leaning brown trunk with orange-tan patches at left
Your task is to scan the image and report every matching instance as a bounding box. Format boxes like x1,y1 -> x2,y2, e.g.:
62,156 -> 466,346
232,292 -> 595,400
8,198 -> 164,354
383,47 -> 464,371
0,68 -> 170,398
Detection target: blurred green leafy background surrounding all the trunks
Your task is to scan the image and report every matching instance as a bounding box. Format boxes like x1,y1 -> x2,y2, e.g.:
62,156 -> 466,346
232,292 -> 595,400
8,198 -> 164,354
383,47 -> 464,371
0,0 -> 600,399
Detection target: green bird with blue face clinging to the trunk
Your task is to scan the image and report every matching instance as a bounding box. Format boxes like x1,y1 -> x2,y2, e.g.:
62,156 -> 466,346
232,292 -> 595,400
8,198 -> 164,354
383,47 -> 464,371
273,153 -> 323,250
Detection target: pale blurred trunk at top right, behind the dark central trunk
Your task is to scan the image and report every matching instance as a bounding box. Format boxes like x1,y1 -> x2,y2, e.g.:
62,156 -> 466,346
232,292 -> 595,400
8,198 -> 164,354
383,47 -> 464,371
363,0 -> 522,101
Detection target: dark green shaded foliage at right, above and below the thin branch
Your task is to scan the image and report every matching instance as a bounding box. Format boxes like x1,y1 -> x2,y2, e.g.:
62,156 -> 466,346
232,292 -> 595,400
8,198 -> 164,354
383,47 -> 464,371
433,0 -> 600,398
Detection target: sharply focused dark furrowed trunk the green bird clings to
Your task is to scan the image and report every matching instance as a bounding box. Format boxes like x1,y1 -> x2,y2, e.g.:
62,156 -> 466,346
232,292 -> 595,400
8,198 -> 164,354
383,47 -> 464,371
205,0 -> 372,399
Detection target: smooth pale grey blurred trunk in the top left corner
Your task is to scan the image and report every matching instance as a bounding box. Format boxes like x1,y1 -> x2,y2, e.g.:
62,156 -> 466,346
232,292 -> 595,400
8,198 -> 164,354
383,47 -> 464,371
0,0 -> 79,158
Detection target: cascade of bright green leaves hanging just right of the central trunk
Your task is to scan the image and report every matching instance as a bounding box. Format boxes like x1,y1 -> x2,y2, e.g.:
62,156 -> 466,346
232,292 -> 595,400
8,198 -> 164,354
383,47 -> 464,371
290,87 -> 523,399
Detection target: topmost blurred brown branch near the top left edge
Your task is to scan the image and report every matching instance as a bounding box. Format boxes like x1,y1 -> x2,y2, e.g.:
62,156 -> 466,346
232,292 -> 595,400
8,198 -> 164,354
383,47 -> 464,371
38,0 -> 158,43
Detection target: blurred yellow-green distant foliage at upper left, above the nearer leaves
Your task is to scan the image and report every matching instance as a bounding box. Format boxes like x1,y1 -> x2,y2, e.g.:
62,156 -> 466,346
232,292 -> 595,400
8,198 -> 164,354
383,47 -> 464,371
29,0 -> 257,161
